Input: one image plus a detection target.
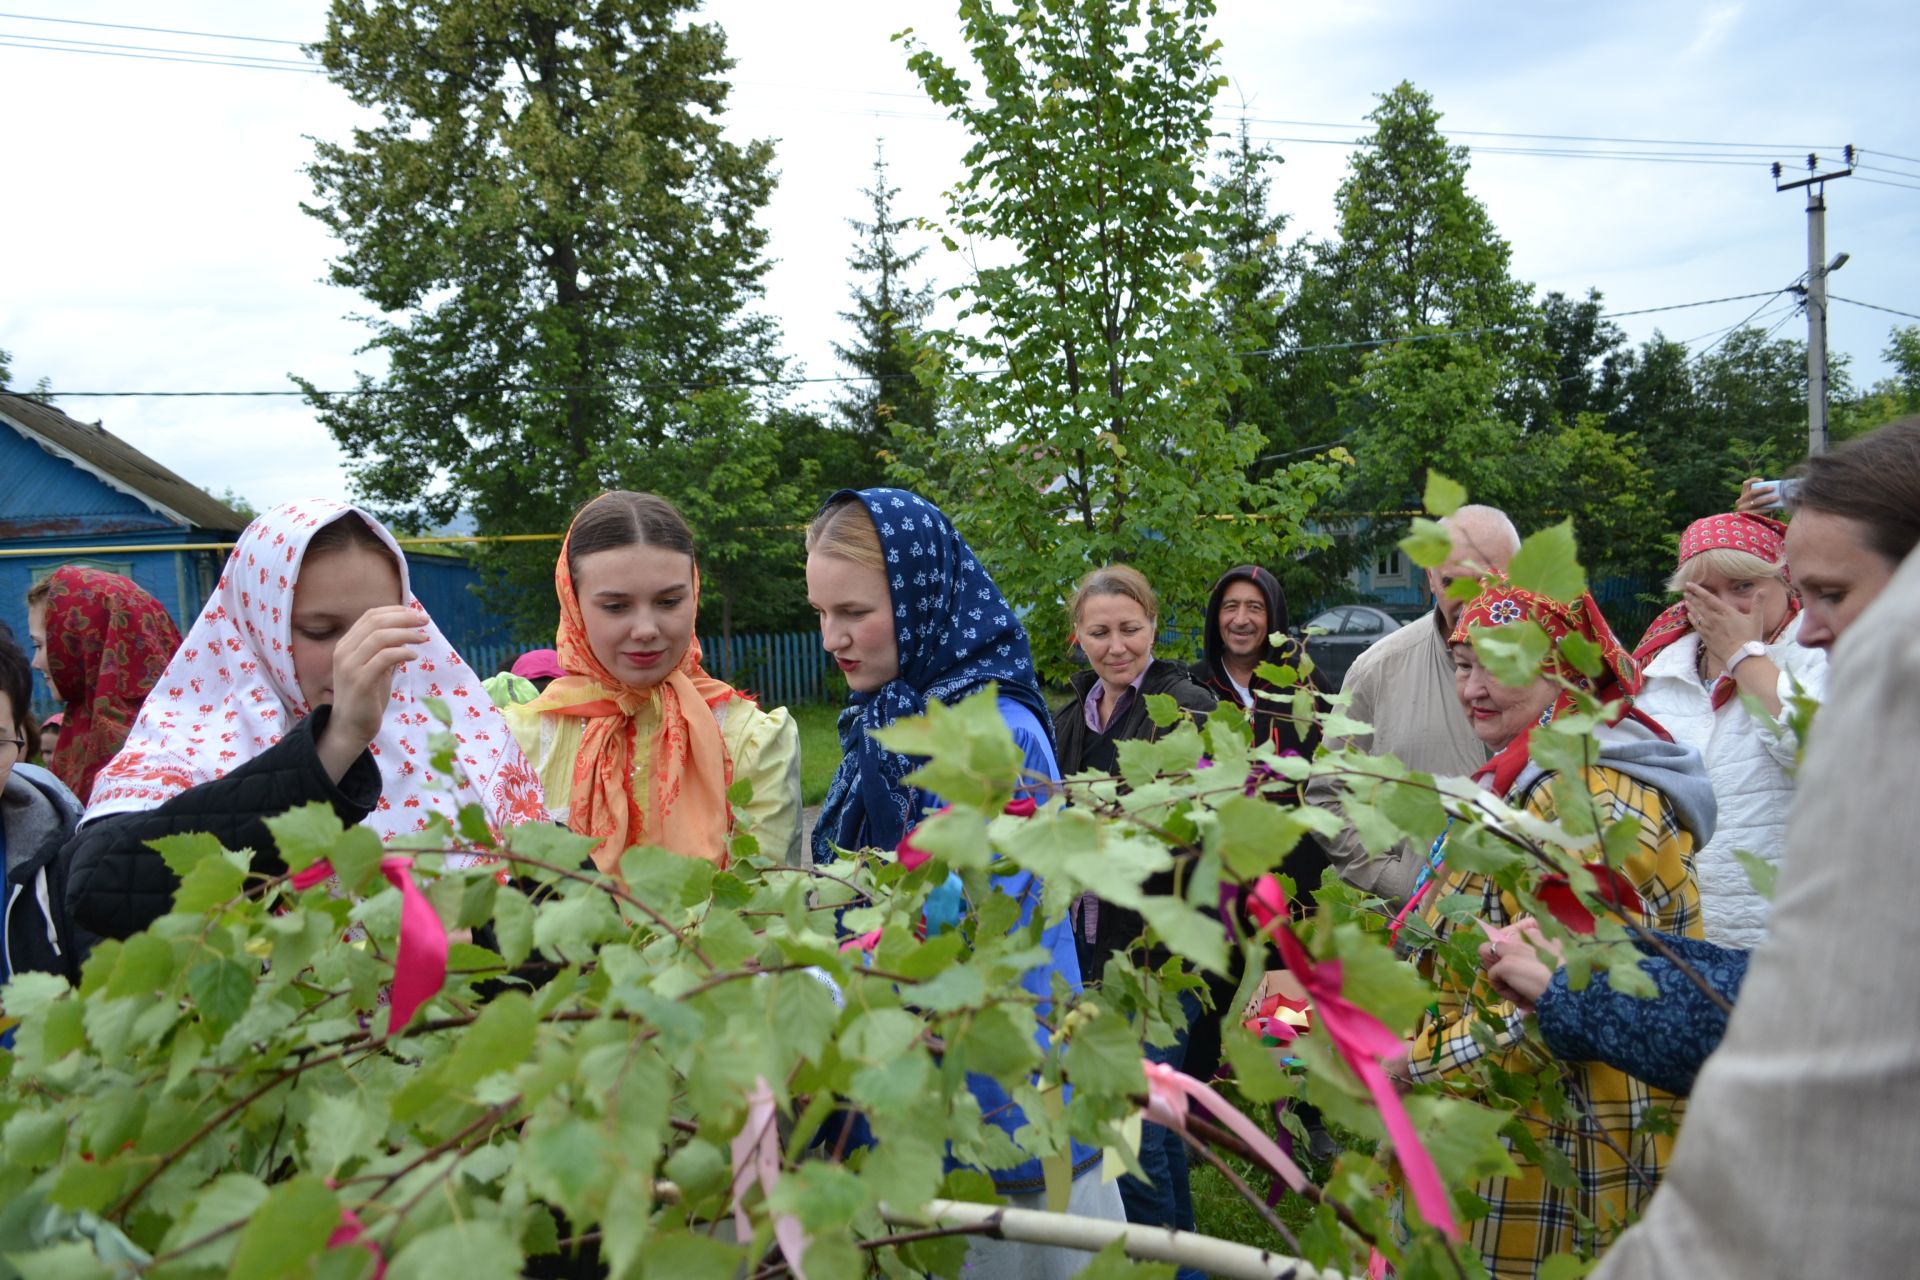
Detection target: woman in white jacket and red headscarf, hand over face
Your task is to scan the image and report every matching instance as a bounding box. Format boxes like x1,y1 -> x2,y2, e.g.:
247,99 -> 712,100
1634,514 -> 1826,948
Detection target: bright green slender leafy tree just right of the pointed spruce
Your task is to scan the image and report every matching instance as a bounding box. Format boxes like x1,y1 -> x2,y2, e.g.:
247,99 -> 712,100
908,0 -> 1329,674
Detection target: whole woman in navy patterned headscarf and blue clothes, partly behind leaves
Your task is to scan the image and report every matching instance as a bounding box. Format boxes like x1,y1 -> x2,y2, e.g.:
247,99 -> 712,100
806,489 -> 1125,1280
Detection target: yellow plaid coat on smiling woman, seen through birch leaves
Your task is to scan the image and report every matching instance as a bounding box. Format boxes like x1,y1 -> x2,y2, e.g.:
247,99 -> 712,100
1409,766 -> 1701,1278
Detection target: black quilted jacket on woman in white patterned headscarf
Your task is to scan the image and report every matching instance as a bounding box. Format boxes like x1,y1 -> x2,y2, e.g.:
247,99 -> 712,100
61,706 -> 380,938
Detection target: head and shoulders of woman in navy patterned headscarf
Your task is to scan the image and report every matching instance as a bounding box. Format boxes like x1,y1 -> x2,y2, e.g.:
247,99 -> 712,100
806,489 -> 1060,862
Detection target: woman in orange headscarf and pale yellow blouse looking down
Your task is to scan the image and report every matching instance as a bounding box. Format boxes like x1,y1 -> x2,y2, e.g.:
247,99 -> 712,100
505,491 -> 801,871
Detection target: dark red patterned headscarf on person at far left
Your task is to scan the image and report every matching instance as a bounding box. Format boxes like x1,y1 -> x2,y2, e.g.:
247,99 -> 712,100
40,564 -> 180,802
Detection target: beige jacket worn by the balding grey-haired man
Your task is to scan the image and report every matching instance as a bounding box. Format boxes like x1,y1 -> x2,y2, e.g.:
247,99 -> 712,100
1308,610 -> 1492,902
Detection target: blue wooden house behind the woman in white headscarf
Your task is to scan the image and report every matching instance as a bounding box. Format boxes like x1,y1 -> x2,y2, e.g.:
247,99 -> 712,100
0,393 -> 511,716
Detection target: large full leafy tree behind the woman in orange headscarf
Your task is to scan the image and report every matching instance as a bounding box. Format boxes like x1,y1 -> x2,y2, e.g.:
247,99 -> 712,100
301,0 -> 791,631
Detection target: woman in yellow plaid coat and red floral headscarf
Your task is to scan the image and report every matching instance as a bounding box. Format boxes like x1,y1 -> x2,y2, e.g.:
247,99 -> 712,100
1407,585 -> 1715,1276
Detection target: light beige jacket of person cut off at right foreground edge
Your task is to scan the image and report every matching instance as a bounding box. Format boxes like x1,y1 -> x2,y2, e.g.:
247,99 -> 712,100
1594,555 -> 1920,1280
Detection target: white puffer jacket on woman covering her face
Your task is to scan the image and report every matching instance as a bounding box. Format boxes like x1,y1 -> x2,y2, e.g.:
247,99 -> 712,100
1636,618 -> 1826,948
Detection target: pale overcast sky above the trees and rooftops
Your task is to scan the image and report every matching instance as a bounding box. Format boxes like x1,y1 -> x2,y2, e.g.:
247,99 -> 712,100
0,0 -> 1920,505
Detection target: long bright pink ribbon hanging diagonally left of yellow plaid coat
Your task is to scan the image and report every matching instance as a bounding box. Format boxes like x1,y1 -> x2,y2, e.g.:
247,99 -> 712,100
1246,875 -> 1461,1242
